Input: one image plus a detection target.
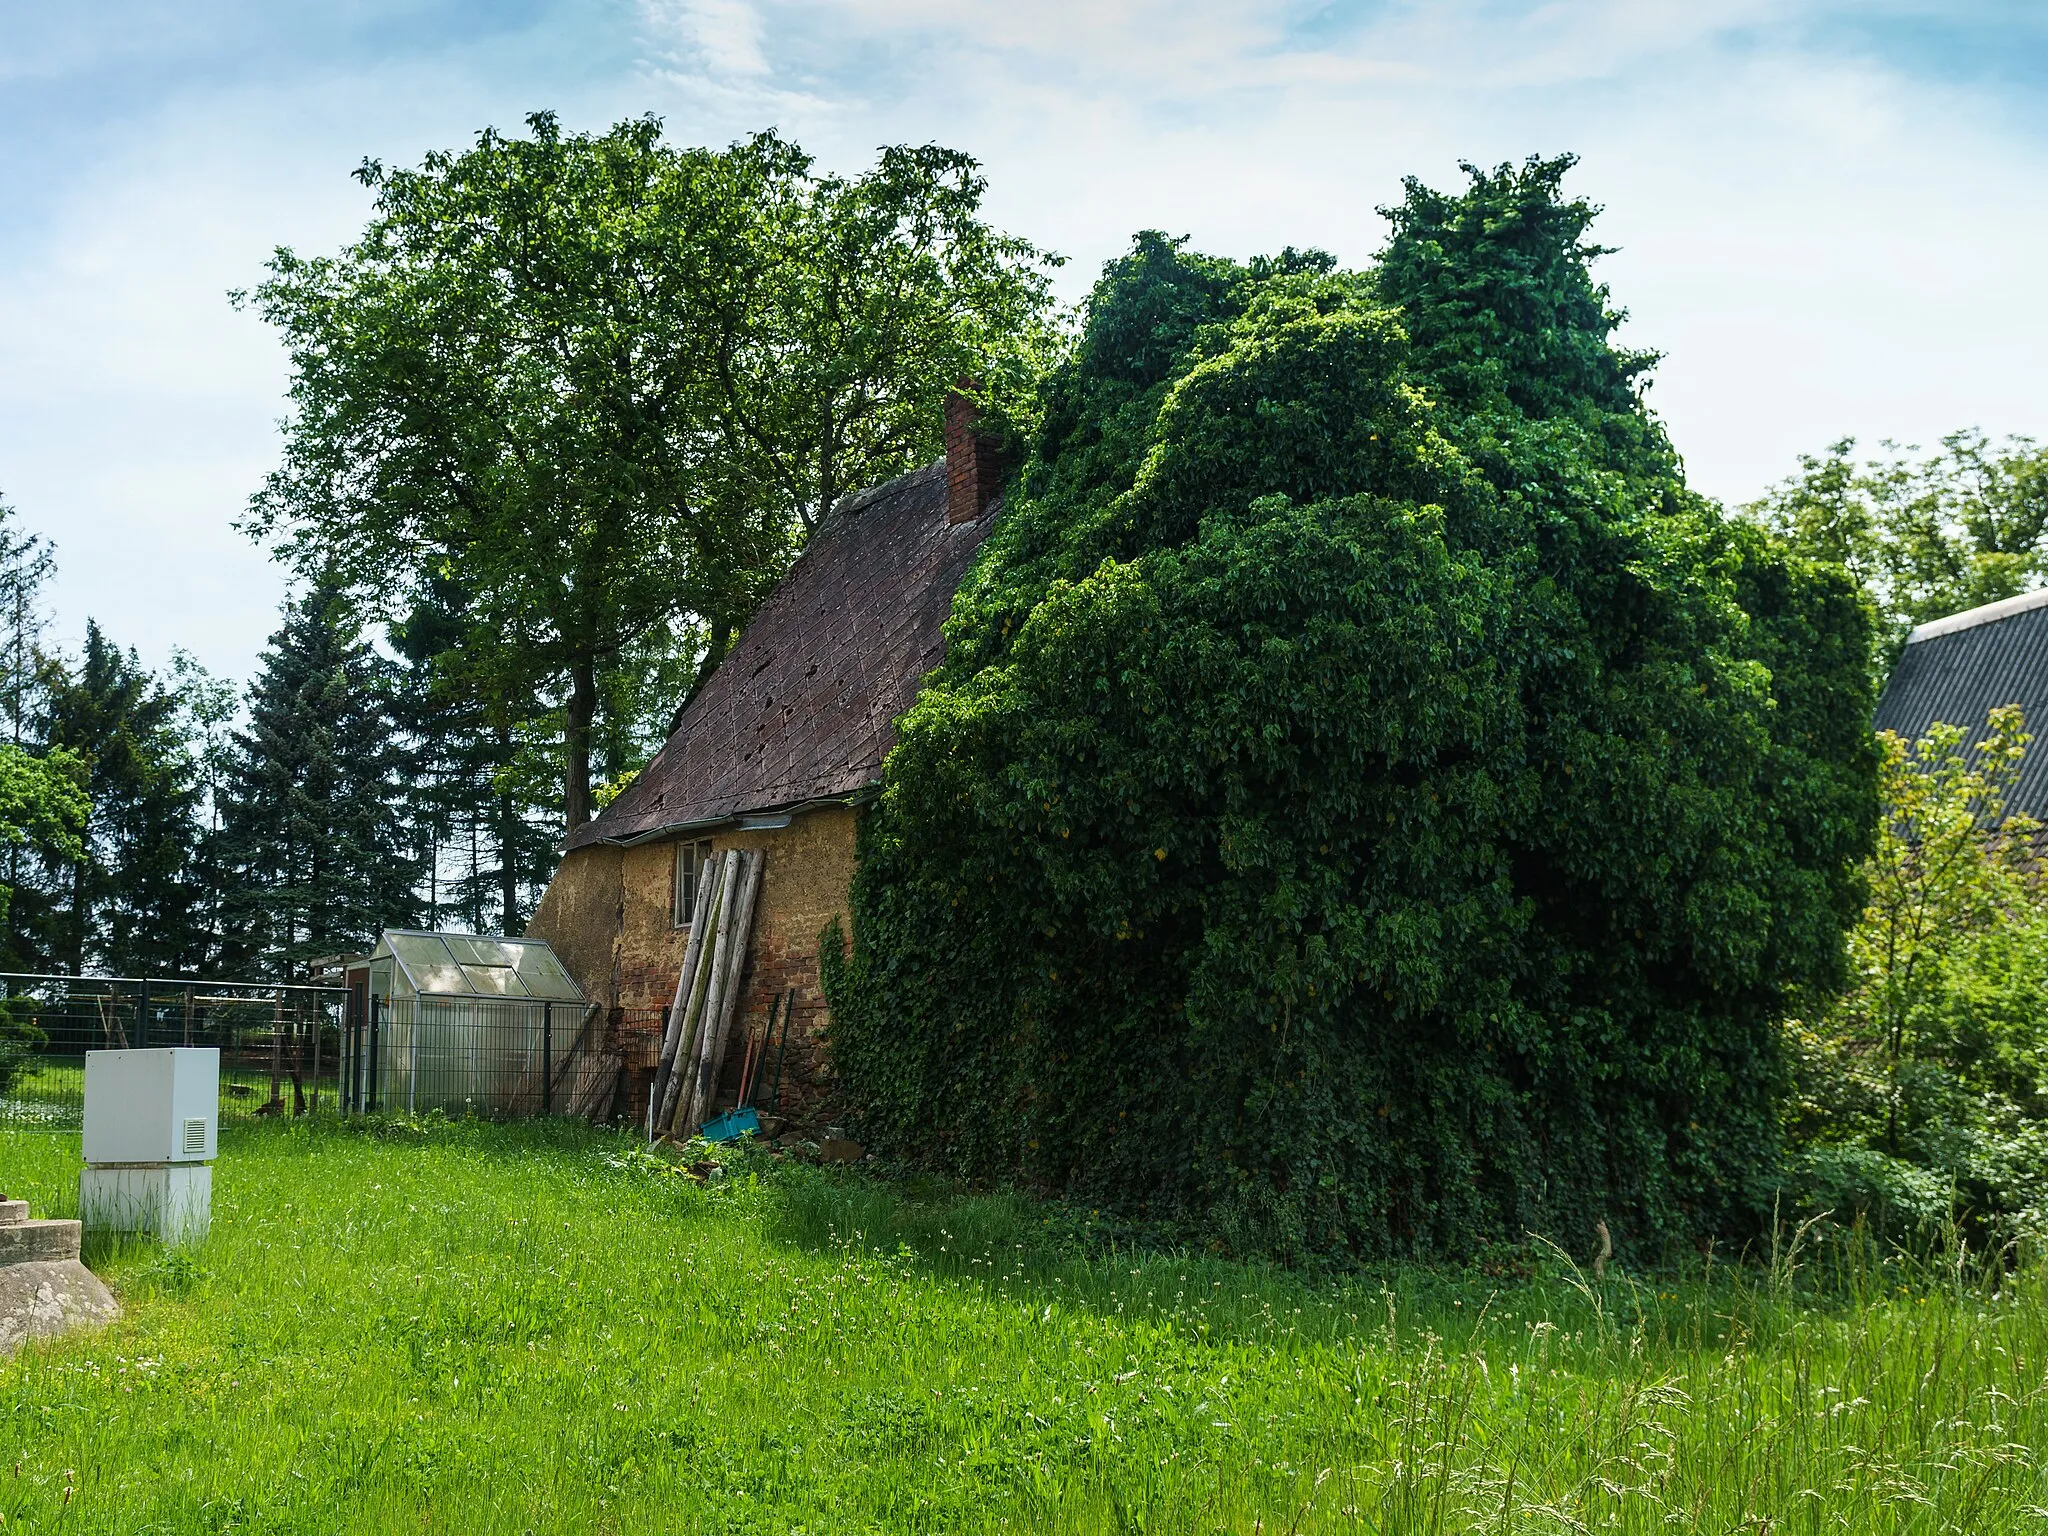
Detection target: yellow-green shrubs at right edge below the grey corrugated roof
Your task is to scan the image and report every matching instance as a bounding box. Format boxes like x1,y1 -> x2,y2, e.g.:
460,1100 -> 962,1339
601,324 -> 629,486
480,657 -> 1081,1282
1790,707 -> 2048,1237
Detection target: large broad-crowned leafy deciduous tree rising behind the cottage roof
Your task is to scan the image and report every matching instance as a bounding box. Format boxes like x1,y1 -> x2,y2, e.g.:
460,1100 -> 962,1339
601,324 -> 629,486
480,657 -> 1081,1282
248,113 -> 1047,827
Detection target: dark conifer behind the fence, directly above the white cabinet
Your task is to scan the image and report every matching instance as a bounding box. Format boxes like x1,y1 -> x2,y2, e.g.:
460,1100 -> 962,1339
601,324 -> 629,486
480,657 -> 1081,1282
49,623 -> 203,975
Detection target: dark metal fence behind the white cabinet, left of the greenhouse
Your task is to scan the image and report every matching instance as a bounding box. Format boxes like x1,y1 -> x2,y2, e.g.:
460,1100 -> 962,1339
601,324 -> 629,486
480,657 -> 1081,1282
0,973 -> 350,1130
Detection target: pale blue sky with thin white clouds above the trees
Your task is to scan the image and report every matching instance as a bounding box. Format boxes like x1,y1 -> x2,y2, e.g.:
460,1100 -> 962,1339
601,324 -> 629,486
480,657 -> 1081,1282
0,0 -> 2048,680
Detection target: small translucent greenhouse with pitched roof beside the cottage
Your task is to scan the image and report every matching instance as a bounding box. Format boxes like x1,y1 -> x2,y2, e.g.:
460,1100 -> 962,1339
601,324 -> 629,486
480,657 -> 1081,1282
348,928 -> 586,1114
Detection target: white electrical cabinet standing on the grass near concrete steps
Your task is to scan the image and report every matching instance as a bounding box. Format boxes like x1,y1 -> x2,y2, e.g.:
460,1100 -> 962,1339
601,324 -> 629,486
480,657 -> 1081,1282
78,1047 -> 221,1243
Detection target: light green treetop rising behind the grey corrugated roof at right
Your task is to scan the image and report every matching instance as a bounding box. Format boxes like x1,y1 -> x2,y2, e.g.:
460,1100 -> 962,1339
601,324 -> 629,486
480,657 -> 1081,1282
1745,430 -> 2048,659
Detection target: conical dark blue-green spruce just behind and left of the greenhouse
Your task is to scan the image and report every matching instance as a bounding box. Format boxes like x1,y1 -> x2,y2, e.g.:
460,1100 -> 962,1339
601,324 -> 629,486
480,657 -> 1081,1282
223,582 -> 420,975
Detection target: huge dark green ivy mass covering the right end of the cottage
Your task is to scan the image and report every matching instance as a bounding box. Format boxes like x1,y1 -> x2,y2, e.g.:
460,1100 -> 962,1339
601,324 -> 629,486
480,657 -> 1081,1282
827,162 -> 1874,1257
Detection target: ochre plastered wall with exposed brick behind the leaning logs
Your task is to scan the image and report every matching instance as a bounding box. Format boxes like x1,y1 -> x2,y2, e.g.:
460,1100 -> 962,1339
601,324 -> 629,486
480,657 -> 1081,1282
526,805 -> 856,1128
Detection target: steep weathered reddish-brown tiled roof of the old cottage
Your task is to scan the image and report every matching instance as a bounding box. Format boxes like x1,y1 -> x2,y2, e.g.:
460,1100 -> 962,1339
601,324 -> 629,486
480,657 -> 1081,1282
567,463 -> 995,848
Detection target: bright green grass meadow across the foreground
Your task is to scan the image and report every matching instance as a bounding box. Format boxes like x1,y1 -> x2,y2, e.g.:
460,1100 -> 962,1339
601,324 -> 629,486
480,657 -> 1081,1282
0,1120 -> 2048,1536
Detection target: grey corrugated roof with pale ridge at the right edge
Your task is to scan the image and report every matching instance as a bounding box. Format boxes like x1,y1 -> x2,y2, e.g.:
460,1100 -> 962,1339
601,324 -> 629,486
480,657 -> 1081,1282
1876,592 -> 2048,819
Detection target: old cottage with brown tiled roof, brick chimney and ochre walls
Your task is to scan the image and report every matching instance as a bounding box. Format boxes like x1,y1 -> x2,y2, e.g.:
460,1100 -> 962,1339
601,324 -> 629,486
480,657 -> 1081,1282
526,397 -> 999,1122
